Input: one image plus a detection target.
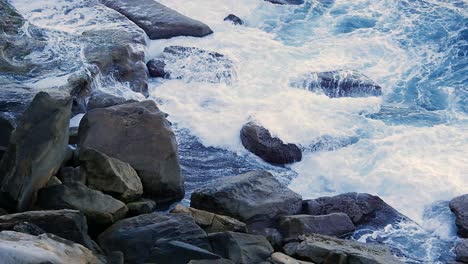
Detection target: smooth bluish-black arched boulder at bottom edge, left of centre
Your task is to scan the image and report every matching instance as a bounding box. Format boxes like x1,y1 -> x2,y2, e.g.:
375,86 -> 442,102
98,213 -> 211,263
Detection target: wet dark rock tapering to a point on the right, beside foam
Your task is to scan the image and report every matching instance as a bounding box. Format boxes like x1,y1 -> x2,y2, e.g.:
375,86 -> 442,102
303,193 -> 410,229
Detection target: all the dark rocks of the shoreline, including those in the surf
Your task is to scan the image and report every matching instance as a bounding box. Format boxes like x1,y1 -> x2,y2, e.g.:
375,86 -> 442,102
0,0 -> 468,264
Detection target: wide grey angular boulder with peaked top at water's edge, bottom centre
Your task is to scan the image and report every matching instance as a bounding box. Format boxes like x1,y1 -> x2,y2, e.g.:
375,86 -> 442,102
191,171 -> 302,228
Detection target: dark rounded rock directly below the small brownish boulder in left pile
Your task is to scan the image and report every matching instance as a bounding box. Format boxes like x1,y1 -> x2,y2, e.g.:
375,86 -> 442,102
38,183 -> 128,229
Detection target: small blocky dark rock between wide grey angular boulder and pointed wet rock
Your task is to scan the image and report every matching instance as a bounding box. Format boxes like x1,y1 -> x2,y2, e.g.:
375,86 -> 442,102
279,213 -> 355,241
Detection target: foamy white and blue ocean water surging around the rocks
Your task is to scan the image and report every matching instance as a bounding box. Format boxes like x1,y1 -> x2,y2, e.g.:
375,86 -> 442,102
8,0 -> 468,263
